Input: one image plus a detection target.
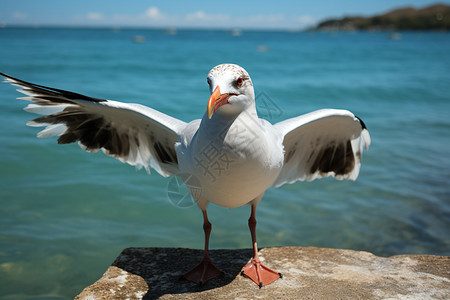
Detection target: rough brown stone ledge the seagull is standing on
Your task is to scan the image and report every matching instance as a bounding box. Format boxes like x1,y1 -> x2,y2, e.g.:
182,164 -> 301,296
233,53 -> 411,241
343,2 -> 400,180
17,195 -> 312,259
75,247 -> 450,300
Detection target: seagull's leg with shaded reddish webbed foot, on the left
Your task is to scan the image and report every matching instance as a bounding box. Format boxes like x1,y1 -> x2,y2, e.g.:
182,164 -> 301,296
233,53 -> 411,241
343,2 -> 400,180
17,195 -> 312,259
184,210 -> 222,285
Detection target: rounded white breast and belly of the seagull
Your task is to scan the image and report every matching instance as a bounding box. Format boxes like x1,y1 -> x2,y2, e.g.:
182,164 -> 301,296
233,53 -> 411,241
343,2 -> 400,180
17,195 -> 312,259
180,115 -> 284,208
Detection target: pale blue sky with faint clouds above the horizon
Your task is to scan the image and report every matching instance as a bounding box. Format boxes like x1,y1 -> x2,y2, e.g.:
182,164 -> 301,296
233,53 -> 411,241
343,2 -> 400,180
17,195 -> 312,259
0,0 -> 450,29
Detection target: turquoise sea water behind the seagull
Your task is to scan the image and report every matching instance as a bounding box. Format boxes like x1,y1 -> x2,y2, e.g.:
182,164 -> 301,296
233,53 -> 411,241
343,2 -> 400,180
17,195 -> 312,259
0,28 -> 450,299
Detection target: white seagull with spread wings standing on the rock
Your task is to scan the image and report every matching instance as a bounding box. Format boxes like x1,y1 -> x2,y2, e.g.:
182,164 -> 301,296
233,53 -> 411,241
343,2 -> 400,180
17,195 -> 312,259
0,64 -> 370,288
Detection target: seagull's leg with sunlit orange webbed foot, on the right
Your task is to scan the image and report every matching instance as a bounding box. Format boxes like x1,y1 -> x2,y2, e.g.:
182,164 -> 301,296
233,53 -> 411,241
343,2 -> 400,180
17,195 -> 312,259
241,205 -> 282,288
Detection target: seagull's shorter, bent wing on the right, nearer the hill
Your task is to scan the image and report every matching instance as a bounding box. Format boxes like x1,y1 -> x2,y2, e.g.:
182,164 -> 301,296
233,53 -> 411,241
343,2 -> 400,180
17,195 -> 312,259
274,109 -> 370,187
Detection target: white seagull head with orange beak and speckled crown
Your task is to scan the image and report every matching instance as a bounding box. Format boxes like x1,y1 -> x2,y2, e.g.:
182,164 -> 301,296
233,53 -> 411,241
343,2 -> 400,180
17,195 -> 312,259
207,64 -> 255,119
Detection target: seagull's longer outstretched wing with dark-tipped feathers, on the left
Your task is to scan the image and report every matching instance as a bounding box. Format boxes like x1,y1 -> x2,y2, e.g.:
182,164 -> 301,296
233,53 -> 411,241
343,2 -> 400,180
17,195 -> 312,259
0,73 -> 186,176
